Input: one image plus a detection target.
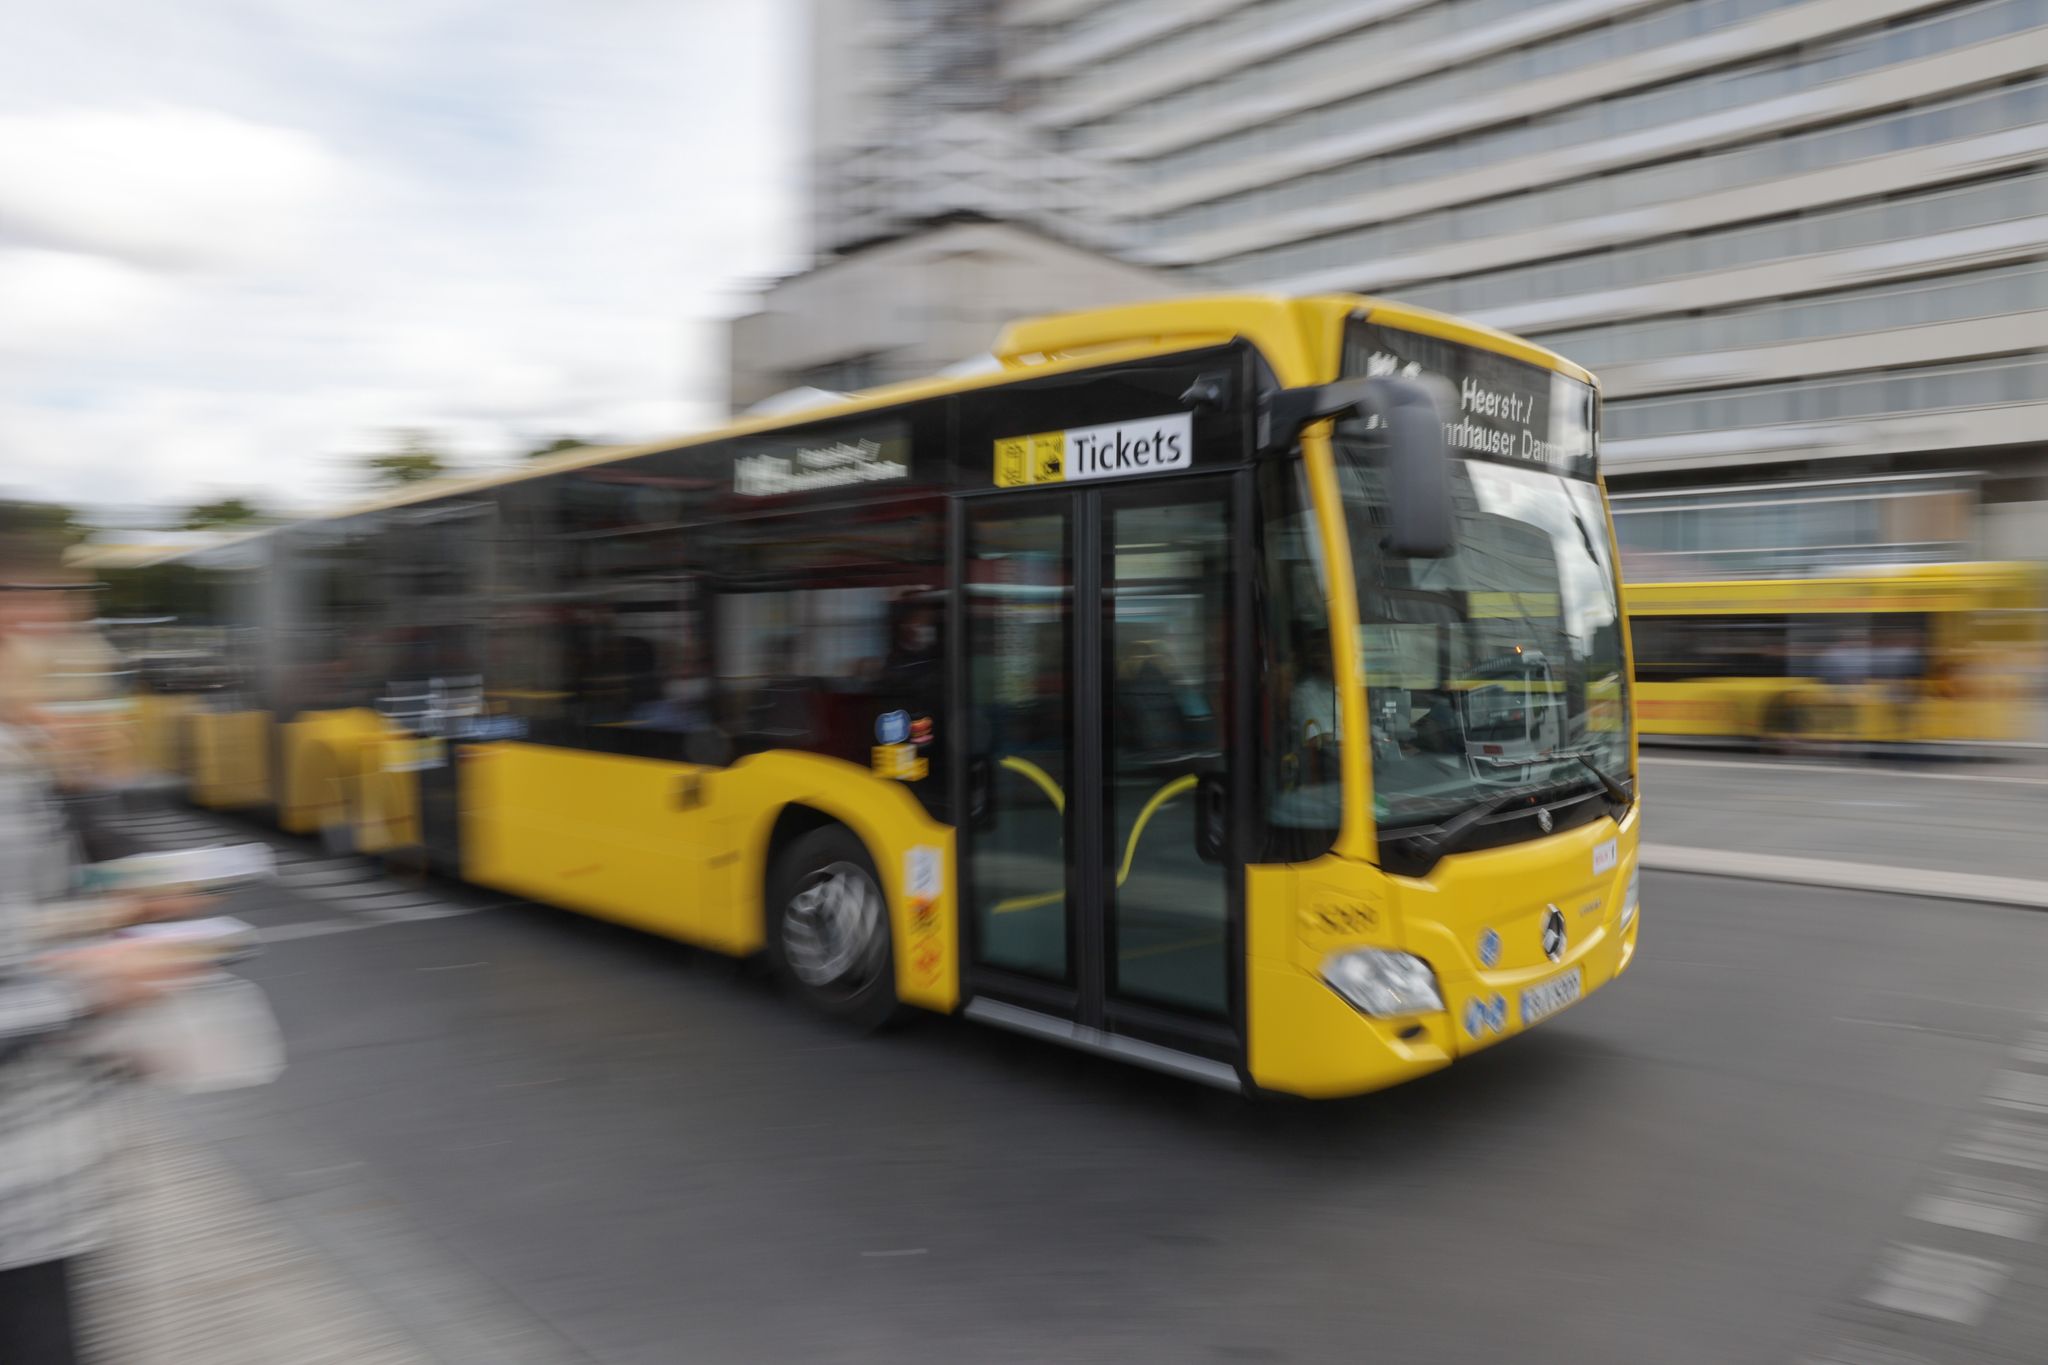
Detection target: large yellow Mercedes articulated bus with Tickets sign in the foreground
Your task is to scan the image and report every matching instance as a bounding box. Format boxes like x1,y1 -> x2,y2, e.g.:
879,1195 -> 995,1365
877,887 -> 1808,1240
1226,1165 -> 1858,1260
140,297 -> 1640,1097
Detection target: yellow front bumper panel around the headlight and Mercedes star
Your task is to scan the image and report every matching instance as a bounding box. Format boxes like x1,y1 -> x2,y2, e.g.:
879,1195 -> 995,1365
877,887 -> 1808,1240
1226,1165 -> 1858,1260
1245,806 -> 1642,1099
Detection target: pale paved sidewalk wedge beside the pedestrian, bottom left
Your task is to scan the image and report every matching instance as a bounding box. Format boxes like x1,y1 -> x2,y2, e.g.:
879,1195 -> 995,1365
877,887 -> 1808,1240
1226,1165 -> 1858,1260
80,1093 -> 434,1365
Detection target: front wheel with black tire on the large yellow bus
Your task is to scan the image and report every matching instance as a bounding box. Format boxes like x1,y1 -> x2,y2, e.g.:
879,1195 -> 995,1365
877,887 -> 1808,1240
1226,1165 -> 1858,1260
766,825 -> 897,1029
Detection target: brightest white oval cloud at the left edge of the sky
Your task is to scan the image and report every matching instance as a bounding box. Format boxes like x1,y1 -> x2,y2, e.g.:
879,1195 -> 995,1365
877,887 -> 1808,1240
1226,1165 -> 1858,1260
0,106 -> 346,270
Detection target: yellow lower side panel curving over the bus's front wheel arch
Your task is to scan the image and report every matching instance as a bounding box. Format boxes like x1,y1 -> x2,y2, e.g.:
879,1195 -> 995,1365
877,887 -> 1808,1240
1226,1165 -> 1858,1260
455,743 -> 961,1011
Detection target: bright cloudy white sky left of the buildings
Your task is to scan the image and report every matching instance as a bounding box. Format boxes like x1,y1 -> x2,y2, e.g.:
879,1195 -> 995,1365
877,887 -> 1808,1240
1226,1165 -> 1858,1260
0,0 -> 805,512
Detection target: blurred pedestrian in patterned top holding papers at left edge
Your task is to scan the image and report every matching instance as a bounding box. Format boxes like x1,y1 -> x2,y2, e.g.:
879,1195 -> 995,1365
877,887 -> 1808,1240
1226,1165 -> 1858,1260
0,536 -> 193,1365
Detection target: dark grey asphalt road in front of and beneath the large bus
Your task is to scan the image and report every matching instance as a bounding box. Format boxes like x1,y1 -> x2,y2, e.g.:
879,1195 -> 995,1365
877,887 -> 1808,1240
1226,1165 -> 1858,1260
108,780 -> 2048,1365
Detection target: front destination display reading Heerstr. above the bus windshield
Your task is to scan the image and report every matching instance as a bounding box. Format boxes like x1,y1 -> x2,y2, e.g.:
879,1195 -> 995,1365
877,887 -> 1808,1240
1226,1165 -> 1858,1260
1343,321 -> 1597,479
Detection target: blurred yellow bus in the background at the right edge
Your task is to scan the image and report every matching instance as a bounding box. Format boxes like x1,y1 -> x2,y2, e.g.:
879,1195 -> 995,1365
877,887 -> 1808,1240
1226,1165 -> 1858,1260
1628,563 -> 2044,745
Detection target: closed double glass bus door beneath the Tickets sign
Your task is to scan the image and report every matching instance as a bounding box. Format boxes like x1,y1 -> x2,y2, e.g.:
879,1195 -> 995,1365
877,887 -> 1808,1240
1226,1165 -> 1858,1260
954,475 -> 1249,1083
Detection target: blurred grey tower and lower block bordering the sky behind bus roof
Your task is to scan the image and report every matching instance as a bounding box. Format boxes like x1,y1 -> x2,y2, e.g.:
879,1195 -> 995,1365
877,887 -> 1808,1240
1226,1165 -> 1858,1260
727,0 -> 1178,409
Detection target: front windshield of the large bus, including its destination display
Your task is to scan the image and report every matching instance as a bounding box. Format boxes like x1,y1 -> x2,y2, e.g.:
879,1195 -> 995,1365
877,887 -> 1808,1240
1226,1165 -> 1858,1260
1335,329 -> 1628,831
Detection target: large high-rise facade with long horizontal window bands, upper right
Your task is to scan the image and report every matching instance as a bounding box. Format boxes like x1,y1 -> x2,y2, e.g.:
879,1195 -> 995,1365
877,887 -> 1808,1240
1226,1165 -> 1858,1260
1001,0 -> 2048,556
